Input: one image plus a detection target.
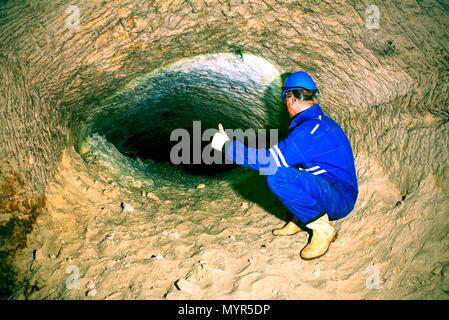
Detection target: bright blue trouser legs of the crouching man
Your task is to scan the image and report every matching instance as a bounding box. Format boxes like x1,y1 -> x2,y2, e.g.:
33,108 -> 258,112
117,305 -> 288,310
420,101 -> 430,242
265,167 -> 357,225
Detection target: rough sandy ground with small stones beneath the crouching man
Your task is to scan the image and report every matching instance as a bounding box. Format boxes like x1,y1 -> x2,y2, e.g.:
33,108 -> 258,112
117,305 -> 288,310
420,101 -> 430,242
11,134 -> 449,299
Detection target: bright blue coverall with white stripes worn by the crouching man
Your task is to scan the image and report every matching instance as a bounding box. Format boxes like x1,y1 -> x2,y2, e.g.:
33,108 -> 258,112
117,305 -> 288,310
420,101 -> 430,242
225,104 -> 358,225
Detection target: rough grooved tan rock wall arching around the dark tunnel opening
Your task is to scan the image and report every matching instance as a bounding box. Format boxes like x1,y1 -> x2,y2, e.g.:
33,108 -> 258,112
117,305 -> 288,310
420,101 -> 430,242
0,0 -> 449,296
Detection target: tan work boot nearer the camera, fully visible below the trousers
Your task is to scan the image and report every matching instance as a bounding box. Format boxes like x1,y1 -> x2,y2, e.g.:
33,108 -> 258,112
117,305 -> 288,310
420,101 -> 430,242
301,214 -> 337,260
